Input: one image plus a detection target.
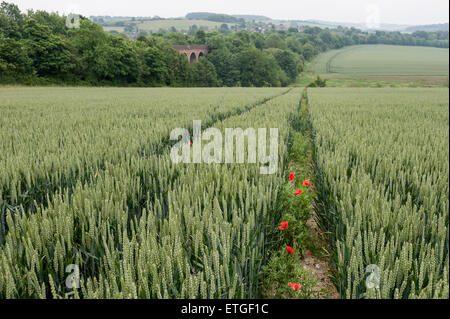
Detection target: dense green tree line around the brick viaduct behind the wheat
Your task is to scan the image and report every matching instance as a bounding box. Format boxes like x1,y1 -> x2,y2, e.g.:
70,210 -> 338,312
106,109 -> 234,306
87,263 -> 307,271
0,2 -> 448,87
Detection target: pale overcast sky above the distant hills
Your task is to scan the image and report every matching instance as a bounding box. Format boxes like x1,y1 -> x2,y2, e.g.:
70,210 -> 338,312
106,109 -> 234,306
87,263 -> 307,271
6,0 -> 449,25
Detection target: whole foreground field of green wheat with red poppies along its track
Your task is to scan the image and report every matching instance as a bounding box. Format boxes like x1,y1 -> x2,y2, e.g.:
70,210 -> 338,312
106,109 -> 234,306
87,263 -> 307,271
0,88 -> 449,298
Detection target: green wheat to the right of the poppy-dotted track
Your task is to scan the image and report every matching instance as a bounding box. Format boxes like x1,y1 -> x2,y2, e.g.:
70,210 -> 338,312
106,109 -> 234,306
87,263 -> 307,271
309,89 -> 449,298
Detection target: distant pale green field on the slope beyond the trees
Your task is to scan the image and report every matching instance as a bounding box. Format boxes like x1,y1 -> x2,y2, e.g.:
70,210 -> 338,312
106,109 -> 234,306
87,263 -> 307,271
310,45 -> 449,77
